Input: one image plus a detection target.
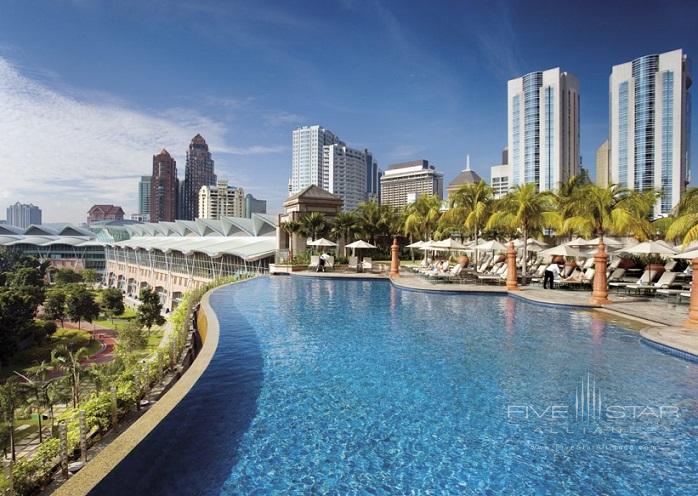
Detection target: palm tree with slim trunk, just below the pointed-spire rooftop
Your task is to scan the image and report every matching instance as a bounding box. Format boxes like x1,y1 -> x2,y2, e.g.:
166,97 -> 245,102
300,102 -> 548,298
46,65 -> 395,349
443,179 -> 494,266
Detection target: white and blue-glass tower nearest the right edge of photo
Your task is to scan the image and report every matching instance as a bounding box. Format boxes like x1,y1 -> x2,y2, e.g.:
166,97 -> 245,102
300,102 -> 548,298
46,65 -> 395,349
609,50 -> 691,216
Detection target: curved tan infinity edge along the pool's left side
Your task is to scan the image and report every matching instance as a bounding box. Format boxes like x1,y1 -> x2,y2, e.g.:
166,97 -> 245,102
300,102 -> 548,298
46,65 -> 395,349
57,279 -> 226,496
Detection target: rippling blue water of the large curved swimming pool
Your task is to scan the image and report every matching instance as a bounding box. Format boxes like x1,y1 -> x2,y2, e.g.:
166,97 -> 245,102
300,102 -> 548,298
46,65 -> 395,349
93,277 -> 698,495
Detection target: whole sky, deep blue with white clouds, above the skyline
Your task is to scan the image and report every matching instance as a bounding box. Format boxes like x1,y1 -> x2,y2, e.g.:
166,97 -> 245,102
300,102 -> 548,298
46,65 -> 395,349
0,0 -> 698,221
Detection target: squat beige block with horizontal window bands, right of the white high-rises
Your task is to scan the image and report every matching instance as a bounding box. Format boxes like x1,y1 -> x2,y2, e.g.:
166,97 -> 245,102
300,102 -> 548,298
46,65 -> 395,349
380,160 -> 444,208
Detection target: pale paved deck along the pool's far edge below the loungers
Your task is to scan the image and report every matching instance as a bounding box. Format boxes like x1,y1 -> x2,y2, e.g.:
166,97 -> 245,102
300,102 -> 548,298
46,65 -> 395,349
293,268 -> 698,359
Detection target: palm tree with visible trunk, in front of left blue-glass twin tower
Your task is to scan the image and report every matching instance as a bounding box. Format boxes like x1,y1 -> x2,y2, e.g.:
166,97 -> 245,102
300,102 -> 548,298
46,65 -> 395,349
486,183 -> 559,284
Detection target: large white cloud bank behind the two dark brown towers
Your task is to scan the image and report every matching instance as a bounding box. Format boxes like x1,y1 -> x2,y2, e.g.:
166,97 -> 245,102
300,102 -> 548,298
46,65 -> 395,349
0,57 -> 286,222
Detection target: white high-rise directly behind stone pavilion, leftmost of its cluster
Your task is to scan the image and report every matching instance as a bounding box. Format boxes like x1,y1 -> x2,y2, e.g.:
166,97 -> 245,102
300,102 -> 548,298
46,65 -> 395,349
289,126 -> 344,196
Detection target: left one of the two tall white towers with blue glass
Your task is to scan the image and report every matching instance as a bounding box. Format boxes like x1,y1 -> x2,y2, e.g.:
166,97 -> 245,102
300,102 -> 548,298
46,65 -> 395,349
507,67 -> 580,191
